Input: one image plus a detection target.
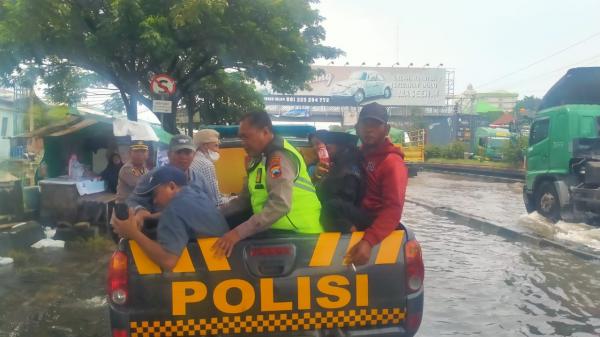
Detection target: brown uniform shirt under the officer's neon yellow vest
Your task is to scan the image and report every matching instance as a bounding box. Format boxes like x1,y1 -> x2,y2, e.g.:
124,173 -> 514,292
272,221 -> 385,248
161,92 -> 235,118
221,150 -> 299,239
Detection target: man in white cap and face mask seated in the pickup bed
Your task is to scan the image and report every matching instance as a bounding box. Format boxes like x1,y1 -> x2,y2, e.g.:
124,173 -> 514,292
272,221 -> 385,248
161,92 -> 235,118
190,129 -> 227,206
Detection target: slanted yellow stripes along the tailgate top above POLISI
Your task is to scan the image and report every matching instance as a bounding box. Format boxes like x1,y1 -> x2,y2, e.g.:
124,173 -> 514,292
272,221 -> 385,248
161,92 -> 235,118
129,230 -> 404,275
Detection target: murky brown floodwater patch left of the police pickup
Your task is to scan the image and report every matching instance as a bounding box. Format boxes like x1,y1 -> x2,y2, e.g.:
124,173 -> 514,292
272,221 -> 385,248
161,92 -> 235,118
0,242 -> 111,337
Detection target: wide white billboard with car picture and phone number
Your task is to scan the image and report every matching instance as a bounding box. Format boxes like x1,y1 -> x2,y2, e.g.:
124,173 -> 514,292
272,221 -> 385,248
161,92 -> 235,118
264,66 -> 447,106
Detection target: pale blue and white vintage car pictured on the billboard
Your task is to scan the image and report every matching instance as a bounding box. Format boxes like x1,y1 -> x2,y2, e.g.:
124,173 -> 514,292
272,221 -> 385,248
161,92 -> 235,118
331,70 -> 392,103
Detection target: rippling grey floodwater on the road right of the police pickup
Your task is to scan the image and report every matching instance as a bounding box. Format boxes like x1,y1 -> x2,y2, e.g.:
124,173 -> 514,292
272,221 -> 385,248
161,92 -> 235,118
403,172 -> 600,337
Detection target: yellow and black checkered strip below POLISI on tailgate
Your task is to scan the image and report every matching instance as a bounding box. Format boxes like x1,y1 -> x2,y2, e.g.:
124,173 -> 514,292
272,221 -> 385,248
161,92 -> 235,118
130,308 -> 405,337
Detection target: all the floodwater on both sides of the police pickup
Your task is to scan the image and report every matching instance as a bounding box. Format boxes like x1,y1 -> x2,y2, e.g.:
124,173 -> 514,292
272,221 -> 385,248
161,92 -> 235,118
0,173 -> 600,337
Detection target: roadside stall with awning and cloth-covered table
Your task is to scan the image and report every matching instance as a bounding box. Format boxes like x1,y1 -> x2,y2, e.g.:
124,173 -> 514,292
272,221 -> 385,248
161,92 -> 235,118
33,114 -> 171,229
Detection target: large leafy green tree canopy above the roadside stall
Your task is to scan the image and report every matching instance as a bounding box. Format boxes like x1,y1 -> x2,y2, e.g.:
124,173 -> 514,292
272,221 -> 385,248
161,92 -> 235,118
0,0 -> 341,132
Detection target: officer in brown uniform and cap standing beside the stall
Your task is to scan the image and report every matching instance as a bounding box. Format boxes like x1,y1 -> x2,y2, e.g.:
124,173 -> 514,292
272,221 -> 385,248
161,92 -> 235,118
117,140 -> 148,203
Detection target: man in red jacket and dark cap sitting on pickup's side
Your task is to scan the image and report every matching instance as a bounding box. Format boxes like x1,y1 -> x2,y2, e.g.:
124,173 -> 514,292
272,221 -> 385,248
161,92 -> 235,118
346,103 -> 408,265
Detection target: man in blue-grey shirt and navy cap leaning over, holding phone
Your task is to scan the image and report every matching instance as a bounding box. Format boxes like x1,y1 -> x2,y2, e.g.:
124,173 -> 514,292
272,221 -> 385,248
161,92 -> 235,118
112,165 -> 229,271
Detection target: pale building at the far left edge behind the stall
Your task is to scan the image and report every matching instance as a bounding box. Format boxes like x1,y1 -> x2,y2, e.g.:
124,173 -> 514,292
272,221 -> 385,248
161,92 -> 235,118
0,88 -> 25,160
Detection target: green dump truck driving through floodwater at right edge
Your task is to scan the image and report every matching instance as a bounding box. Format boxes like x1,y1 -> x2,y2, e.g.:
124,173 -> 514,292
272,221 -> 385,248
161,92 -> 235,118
523,67 -> 600,222
